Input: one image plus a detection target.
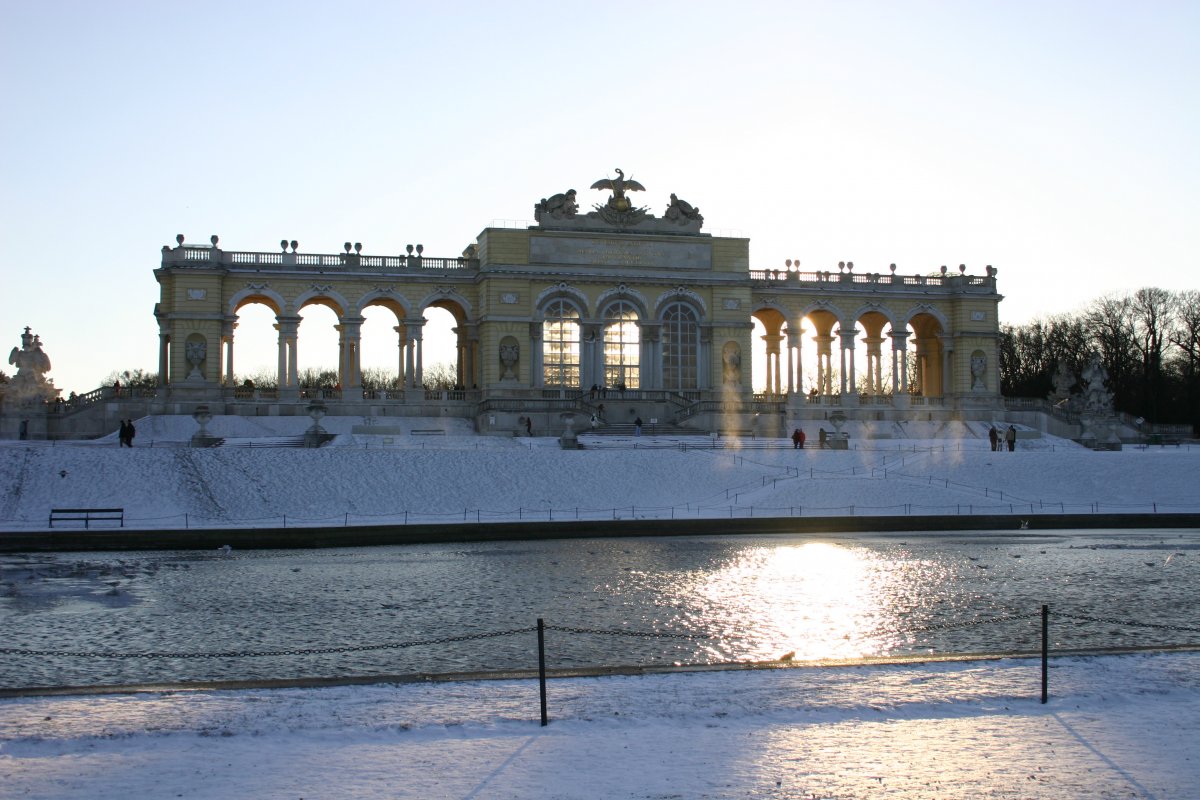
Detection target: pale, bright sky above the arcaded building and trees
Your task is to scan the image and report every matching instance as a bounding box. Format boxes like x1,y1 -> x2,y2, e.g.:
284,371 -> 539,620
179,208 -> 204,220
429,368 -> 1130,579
0,0 -> 1200,393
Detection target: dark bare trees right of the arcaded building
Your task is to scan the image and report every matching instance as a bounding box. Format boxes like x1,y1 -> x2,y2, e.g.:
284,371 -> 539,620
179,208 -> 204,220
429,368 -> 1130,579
1000,288 -> 1200,427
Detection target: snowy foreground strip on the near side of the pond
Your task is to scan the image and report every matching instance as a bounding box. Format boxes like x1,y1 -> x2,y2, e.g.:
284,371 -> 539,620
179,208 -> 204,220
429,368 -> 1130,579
0,654 -> 1200,800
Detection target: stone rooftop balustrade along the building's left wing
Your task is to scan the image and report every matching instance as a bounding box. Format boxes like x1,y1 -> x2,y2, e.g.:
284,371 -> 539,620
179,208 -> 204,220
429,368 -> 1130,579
162,245 -> 479,272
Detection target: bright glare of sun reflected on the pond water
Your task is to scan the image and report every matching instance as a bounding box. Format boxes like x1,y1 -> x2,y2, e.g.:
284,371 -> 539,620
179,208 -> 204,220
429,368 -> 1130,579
692,542 -> 919,661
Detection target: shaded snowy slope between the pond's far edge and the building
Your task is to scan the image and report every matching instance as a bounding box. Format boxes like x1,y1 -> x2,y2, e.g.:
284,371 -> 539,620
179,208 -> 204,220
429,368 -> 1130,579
0,416 -> 1200,530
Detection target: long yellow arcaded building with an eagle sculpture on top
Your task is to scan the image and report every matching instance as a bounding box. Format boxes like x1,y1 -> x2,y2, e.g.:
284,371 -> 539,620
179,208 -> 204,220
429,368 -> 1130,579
140,165 -> 1002,433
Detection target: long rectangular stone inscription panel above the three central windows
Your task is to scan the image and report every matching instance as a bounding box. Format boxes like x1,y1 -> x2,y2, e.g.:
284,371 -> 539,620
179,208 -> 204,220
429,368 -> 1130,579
529,236 -> 713,270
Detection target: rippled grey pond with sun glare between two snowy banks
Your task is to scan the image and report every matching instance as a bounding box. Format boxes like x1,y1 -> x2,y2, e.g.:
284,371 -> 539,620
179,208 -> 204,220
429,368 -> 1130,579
0,530 -> 1200,687
